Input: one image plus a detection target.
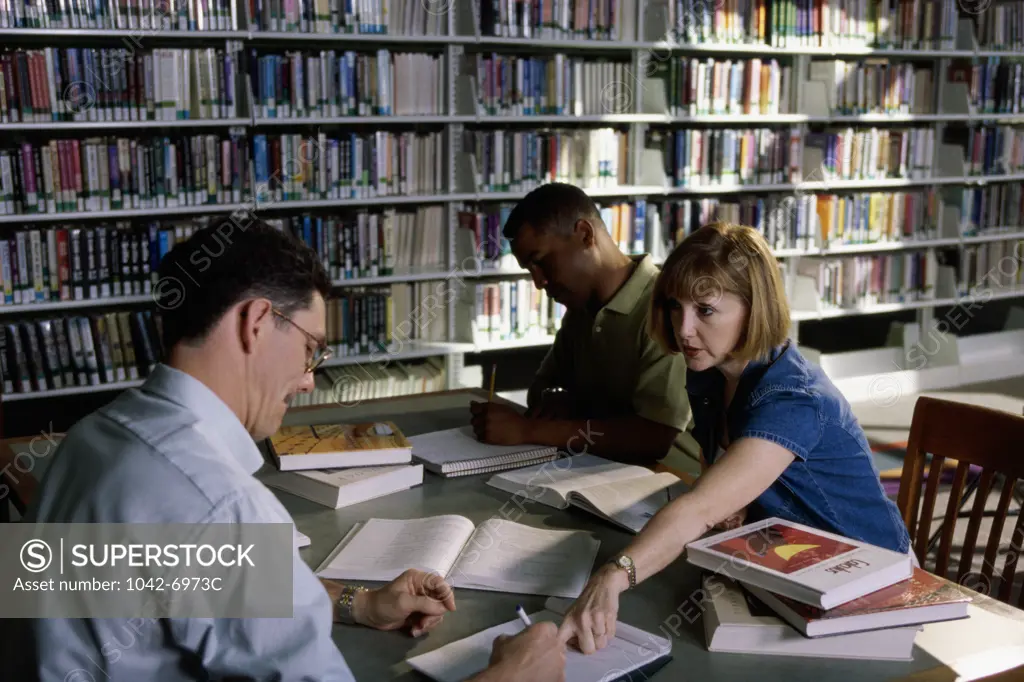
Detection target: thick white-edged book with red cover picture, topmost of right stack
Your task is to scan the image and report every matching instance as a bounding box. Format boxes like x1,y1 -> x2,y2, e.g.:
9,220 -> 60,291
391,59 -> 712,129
686,517 -> 913,609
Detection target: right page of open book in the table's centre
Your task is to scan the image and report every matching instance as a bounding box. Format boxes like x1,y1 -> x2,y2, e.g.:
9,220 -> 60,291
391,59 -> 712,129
449,519 -> 600,598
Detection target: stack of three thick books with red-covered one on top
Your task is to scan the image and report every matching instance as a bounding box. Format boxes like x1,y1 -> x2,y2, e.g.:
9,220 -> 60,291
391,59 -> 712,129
686,518 -> 971,660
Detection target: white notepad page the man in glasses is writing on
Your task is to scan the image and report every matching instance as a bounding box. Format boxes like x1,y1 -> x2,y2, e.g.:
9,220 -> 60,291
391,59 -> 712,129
408,610 -> 667,682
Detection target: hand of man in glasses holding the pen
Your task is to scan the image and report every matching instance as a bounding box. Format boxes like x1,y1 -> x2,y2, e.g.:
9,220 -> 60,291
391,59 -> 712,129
474,623 -> 565,682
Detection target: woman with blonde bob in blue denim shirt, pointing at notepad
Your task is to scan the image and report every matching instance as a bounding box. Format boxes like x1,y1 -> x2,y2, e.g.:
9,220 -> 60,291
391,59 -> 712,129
561,223 -> 910,653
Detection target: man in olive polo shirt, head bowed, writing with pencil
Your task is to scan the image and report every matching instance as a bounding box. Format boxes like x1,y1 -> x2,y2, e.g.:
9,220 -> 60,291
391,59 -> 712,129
470,183 -> 700,476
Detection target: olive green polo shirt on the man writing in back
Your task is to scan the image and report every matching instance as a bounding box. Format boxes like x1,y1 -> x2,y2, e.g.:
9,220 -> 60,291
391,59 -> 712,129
536,254 -> 700,476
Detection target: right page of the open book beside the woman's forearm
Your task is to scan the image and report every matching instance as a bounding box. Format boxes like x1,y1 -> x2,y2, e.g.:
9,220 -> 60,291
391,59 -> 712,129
569,471 -> 689,532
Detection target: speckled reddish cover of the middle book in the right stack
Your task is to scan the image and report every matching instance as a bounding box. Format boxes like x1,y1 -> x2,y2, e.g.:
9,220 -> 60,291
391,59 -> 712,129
775,567 -> 971,621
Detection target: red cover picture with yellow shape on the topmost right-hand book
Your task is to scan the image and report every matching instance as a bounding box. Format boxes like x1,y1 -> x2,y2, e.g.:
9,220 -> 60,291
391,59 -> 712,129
709,523 -> 858,574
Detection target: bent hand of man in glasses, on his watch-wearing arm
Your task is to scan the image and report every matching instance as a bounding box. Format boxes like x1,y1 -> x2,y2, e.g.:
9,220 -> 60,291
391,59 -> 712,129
323,568 -> 455,637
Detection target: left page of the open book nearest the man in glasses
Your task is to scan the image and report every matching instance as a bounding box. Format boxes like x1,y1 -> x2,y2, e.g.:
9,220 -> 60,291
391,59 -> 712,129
317,515 -> 473,581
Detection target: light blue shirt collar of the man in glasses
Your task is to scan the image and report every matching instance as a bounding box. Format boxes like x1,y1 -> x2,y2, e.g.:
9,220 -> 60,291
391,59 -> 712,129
139,364 -> 263,474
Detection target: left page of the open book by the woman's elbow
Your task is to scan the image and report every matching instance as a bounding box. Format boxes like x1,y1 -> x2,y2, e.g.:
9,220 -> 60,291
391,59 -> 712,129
487,455 -> 653,506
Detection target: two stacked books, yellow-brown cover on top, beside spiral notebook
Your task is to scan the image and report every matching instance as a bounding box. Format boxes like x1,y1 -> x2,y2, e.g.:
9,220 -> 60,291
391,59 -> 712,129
264,422 -> 423,509
